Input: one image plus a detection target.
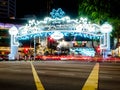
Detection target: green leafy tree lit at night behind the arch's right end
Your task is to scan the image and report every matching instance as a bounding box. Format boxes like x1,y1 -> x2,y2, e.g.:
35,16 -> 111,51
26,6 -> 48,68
78,0 -> 120,49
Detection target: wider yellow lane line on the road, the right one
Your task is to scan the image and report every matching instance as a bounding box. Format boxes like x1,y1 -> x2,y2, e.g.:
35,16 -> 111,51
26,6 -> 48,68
82,63 -> 99,90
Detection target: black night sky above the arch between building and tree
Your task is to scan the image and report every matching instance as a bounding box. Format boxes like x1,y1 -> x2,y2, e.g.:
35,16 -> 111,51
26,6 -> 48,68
16,0 -> 78,18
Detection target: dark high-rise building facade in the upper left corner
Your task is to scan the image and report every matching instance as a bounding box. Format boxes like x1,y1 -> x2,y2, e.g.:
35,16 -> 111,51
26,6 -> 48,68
0,0 -> 16,19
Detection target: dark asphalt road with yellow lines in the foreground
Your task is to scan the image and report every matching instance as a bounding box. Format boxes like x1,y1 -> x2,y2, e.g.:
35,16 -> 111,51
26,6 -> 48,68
0,61 -> 120,90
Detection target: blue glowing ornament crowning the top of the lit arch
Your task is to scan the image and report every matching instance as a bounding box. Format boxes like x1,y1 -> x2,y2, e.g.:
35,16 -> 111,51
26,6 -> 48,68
50,8 -> 65,19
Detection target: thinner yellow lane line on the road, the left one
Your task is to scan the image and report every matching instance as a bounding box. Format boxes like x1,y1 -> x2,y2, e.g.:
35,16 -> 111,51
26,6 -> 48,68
30,62 -> 45,90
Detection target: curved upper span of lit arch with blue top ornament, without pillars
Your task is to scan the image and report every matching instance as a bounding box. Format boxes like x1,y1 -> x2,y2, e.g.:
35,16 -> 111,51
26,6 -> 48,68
8,8 -> 112,59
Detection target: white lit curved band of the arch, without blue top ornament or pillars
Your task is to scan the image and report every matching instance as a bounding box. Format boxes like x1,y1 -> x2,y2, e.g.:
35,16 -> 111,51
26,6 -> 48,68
18,11 -> 101,39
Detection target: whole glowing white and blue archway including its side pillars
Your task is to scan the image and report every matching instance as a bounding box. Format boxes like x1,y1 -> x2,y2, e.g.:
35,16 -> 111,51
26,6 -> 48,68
10,8 -> 112,59
